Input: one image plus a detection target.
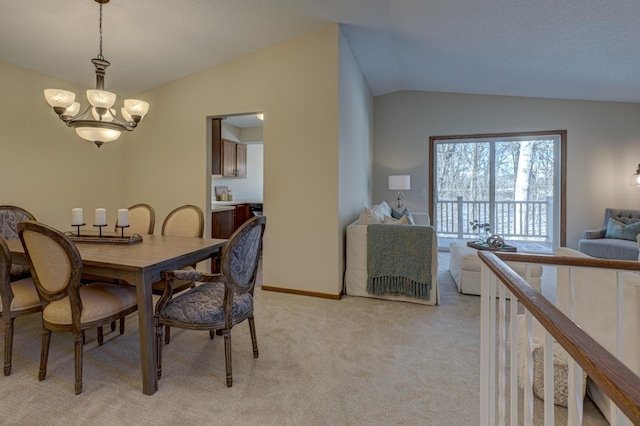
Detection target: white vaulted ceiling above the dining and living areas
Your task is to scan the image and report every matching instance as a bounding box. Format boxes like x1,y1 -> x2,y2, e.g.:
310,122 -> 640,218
0,0 -> 640,102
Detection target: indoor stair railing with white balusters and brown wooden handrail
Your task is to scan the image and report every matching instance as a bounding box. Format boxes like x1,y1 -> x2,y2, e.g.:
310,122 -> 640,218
479,251 -> 640,426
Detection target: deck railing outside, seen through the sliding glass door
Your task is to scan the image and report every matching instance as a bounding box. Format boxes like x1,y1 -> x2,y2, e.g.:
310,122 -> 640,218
434,197 -> 553,241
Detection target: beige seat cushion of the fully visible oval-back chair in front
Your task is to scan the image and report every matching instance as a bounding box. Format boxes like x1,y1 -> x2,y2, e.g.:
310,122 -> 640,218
42,283 -> 137,325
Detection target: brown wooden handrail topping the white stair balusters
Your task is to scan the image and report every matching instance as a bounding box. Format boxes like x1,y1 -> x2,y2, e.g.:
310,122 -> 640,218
478,250 -> 640,424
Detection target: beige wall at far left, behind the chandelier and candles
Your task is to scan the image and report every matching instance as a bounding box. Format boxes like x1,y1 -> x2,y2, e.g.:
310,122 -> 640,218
0,62 -> 126,230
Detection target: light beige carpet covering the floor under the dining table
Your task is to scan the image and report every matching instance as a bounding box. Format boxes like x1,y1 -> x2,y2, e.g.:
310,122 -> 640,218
0,253 -> 601,425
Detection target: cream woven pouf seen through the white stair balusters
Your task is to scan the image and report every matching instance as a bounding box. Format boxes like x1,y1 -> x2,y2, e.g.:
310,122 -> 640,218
532,343 -> 587,407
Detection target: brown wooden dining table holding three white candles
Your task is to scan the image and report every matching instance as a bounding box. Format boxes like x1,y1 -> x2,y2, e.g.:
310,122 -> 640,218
7,231 -> 227,395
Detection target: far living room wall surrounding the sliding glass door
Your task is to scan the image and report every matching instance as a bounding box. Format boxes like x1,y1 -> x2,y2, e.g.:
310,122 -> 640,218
373,92 -> 640,248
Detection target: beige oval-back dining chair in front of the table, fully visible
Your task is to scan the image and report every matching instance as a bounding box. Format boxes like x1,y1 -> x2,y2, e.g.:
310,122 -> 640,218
18,221 -> 138,395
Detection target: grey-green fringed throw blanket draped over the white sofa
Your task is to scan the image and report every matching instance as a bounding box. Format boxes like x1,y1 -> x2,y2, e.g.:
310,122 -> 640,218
367,224 -> 437,300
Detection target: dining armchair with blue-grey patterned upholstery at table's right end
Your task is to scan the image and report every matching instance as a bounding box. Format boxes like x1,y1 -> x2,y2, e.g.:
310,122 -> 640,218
155,216 -> 267,386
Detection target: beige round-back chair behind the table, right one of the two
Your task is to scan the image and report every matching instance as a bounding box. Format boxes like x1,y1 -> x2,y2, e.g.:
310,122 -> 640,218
152,204 -> 204,344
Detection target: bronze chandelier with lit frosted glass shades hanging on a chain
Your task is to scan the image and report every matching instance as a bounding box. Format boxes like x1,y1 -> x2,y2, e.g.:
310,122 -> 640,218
44,0 -> 149,148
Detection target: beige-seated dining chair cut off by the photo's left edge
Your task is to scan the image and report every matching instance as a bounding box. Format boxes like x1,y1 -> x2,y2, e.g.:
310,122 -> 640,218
0,238 -> 42,376
